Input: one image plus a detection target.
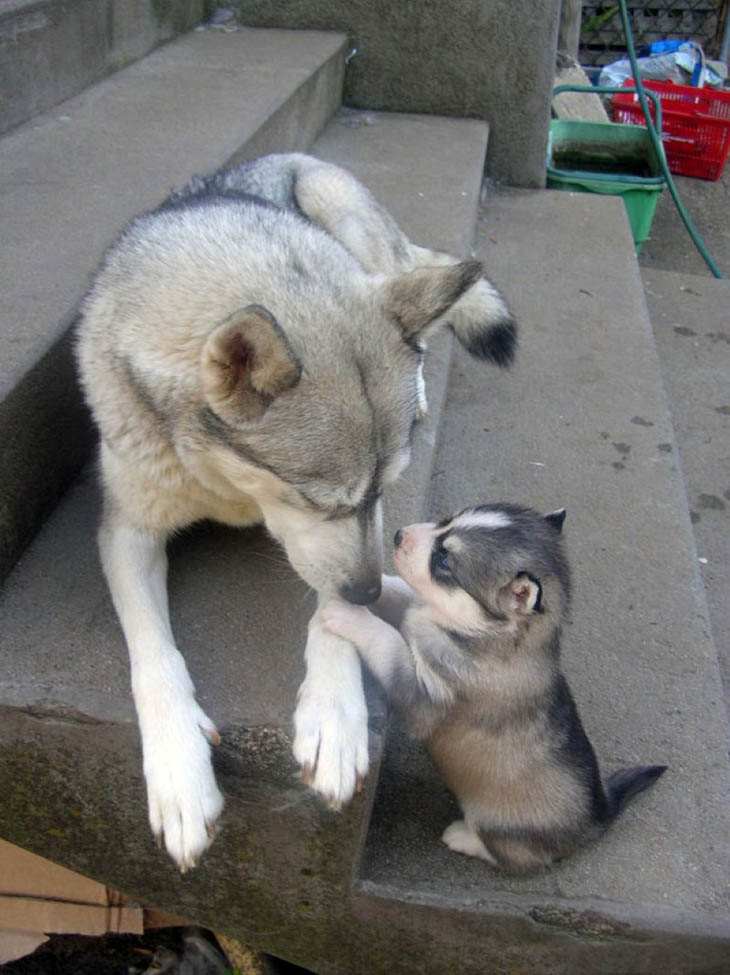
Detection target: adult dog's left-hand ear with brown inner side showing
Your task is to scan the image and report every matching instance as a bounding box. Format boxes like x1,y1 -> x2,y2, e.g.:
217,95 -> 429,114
201,305 -> 301,424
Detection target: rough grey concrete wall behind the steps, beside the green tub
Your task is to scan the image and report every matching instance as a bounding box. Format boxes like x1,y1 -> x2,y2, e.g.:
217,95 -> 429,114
235,0 -> 560,186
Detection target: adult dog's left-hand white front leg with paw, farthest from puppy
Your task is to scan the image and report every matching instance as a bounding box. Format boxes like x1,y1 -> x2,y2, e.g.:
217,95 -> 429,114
99,506 -> 223,872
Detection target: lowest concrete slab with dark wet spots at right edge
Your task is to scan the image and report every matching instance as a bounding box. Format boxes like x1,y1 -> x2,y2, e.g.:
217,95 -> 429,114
641,268 -> 730,700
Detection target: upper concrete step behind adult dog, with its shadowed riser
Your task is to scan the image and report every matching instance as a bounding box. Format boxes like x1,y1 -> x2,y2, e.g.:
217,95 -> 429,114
0,29 -> 345,578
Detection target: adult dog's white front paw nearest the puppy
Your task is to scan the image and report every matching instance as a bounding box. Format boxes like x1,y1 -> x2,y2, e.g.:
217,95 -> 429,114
294,679 -> 368,809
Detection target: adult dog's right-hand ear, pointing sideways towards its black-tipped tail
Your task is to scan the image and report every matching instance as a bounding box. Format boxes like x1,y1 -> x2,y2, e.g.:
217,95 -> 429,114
386,261 -> 483,342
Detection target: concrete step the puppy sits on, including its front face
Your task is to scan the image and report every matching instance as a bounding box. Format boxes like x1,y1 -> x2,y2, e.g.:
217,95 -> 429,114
356,191 -> 730,975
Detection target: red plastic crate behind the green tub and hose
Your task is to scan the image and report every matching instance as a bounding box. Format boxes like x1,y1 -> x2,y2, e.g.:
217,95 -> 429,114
611,80 -> 730,179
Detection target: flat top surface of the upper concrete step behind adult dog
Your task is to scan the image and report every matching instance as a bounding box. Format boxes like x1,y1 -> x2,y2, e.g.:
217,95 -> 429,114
0,29 -> 344,400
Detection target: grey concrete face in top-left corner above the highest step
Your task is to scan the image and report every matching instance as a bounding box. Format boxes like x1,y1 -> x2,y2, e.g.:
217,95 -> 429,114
0,0 -> 210,132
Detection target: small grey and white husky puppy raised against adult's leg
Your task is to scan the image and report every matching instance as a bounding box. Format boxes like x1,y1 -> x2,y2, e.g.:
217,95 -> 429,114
323,504 -> 666,873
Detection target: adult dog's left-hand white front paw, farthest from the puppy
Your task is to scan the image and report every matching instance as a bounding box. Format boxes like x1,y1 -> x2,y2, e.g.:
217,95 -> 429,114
140,696 -> 223,873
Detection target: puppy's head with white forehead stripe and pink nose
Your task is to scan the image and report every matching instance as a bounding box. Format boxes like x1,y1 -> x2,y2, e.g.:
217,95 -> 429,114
394,504 -> 570,637
